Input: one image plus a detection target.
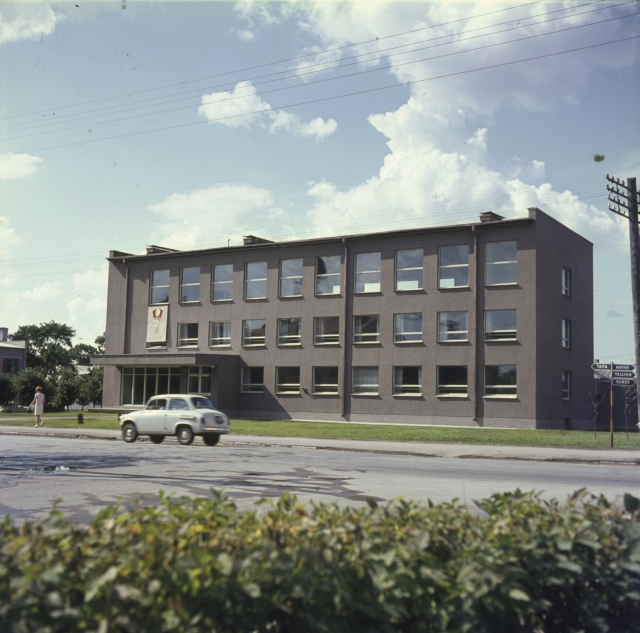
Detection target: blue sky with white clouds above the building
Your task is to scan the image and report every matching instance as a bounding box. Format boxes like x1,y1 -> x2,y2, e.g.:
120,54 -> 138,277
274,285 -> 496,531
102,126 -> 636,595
0,0 -> 640,362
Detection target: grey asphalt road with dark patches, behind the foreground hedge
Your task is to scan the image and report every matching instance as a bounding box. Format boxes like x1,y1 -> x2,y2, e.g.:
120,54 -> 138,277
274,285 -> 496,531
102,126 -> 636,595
0,435 -> 640,522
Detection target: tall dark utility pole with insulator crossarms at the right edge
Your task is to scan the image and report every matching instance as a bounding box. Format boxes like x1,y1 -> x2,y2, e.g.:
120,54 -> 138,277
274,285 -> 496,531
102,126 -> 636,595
607,174 -> 640,440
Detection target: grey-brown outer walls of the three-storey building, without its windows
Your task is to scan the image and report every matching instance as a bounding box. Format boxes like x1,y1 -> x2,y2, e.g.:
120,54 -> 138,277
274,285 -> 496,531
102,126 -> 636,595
93,208 -> 593,428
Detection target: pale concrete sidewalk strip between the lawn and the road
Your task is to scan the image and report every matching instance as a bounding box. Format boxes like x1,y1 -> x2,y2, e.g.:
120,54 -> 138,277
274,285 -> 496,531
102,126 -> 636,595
0,422 -> 640,466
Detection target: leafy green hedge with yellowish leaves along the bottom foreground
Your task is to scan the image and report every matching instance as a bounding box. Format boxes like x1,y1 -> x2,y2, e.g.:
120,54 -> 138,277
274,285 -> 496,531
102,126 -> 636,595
0,491 -> 640,633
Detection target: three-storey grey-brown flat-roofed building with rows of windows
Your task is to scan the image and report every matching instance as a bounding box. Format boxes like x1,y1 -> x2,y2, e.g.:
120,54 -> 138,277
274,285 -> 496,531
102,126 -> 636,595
93,208 -> 593,428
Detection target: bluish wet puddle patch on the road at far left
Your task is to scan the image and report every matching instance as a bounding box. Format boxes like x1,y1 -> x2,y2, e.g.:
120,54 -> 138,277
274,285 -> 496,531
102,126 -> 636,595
0,453 -> 140,474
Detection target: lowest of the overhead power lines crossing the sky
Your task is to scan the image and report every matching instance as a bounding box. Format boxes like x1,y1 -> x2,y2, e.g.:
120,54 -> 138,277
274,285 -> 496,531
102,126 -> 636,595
12,35 -> 640,152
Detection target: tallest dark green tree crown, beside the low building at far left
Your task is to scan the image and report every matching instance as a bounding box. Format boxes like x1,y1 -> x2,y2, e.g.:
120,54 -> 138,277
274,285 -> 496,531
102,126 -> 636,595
13,321 -> 76,376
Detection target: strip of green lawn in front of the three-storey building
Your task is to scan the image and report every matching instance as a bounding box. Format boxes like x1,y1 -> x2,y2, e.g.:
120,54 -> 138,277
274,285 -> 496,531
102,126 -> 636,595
0,413 -> 640,449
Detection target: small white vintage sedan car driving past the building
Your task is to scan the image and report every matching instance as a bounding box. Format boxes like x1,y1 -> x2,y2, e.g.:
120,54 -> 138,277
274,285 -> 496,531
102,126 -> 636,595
118,393 -> 230,446
